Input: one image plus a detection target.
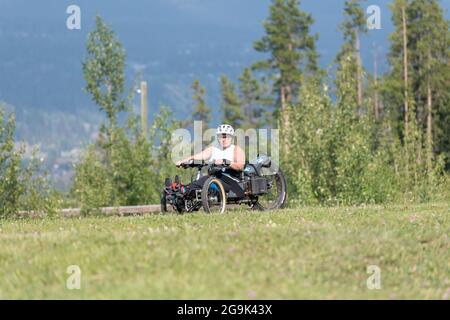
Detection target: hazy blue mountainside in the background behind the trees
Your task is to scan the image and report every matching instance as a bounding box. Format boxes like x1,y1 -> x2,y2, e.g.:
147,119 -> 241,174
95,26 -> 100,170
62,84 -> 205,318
0,0 -> 450,190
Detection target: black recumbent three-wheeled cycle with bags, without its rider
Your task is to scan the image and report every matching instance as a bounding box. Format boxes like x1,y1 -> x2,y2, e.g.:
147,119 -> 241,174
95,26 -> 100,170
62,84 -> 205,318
161,155 -> 287,213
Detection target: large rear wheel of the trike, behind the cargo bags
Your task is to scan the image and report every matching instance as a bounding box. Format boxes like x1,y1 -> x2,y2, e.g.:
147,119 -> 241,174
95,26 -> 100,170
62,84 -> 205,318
254,169 -> 287,211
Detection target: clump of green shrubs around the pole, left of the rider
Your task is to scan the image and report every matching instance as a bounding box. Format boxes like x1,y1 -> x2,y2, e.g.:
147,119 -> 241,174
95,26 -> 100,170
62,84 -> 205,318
71,107 -> 180,214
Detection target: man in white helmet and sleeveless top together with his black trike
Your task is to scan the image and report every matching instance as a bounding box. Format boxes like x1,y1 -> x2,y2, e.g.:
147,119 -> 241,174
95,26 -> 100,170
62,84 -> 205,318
161,124 -> 287,213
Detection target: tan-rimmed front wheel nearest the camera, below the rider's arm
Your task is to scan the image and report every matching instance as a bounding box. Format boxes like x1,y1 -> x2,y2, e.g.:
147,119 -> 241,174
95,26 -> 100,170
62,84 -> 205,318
202,176 -> 227,213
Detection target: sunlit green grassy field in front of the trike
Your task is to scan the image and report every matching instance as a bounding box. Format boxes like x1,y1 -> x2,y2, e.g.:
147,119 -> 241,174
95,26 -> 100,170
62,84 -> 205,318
0,203 -> 450,299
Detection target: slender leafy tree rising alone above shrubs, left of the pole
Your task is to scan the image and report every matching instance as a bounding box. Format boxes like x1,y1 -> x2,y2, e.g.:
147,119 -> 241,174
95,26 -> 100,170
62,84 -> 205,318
83,16 -> 125,148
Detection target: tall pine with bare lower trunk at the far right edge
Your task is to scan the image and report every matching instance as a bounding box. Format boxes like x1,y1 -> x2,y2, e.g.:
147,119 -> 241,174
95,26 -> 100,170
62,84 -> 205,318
407,0 -> 450,172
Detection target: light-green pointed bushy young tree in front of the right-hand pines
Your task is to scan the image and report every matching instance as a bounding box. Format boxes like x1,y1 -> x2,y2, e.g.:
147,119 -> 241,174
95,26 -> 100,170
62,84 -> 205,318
329,53 -> 376,203
